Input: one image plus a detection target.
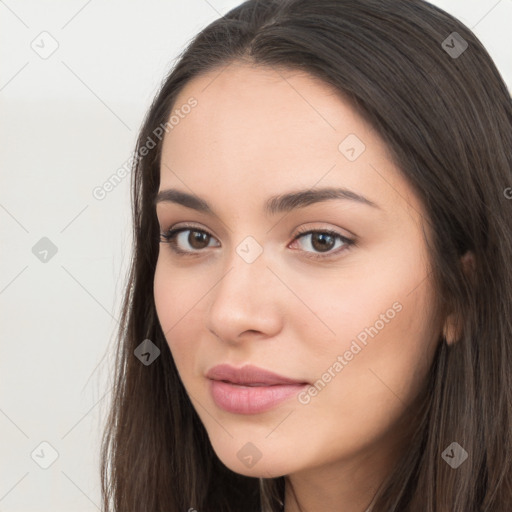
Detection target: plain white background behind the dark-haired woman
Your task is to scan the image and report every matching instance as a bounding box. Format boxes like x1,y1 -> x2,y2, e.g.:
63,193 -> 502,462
0,0 -> 512,512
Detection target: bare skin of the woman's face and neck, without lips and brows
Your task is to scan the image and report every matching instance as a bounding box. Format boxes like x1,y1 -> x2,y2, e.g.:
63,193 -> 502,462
154,62 -> 445,512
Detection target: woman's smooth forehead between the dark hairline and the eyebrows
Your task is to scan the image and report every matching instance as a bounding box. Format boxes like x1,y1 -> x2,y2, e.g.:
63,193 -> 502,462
161,63 -> 419,224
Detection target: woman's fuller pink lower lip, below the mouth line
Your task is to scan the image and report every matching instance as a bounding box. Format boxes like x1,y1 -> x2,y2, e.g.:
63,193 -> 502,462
210,380 -> 308,414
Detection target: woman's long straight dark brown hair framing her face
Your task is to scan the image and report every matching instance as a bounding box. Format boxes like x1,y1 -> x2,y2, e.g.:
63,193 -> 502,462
101,0 -> 512,512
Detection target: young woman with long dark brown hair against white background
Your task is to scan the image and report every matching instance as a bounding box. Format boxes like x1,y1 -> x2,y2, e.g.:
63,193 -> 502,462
101,0 -> 512,512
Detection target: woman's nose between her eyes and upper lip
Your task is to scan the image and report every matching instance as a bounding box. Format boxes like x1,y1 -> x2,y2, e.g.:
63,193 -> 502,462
206,243 -> 289,344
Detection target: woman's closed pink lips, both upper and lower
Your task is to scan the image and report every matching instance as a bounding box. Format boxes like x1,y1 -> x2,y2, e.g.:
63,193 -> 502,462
206,364 -> 309,414
